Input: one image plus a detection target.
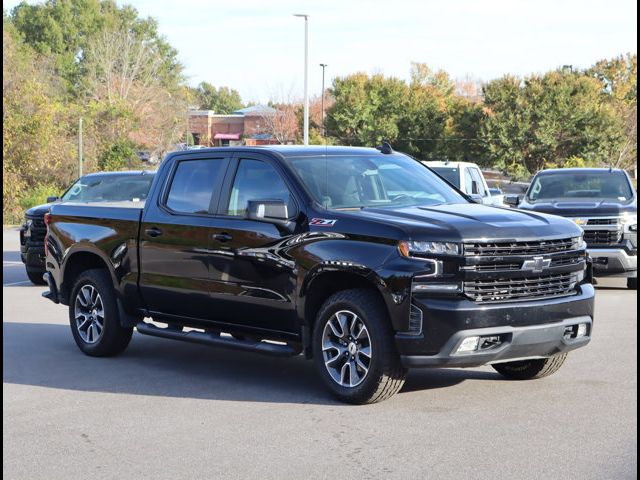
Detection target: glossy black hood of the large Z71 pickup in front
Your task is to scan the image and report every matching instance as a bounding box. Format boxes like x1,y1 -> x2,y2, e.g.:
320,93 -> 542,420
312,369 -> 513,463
340,203 -> 582,242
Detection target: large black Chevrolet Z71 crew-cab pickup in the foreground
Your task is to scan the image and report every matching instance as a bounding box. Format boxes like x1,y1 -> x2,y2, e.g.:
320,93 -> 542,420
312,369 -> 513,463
44,146 -> 594,403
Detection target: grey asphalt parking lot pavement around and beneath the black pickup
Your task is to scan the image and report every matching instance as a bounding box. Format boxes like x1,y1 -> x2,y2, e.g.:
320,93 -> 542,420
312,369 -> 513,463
2,230 -> 637,480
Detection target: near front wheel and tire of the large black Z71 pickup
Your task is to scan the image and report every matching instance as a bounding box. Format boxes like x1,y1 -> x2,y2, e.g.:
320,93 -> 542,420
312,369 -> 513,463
313,289 -> 407,404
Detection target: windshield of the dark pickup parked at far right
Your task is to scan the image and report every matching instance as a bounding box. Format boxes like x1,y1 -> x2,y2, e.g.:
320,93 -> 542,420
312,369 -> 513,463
527,171 -> 633,202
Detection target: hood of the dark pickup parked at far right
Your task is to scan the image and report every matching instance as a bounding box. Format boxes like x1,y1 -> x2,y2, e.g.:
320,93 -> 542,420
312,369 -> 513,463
520,199 -> 638,217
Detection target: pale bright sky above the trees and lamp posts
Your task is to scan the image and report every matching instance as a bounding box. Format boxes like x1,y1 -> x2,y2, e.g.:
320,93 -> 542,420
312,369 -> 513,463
3,0 -> 637,101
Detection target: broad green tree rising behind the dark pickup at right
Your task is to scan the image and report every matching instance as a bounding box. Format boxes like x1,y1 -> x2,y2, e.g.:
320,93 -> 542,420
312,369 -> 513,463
481,71 -> 622,176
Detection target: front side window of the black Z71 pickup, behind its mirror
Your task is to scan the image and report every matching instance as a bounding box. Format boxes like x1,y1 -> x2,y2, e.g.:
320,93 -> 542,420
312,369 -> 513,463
227,159 -> 296,216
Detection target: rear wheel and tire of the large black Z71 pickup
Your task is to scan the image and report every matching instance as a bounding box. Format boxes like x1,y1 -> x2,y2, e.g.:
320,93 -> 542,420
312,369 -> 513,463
69,269 -> 133,357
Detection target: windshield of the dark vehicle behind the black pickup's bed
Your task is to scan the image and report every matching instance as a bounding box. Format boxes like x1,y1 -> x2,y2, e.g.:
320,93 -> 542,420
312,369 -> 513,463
62,173 -> 153,202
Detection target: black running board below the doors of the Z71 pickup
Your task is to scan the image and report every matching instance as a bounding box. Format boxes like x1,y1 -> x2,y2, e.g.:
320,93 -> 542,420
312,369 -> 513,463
136,322 -> 301,357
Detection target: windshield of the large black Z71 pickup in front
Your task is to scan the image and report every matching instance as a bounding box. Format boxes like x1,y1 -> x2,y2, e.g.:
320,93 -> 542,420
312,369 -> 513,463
289,155 -> 467,209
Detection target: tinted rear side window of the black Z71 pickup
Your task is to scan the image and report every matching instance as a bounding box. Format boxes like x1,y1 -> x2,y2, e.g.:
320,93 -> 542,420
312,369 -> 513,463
167,159 -> 225,213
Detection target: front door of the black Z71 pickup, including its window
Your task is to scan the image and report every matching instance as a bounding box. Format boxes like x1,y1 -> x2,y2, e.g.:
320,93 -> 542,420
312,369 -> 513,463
210,155 -> 298,332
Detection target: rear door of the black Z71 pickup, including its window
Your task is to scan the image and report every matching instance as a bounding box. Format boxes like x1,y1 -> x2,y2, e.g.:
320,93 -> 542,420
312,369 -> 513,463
140,154 -> 229,319
